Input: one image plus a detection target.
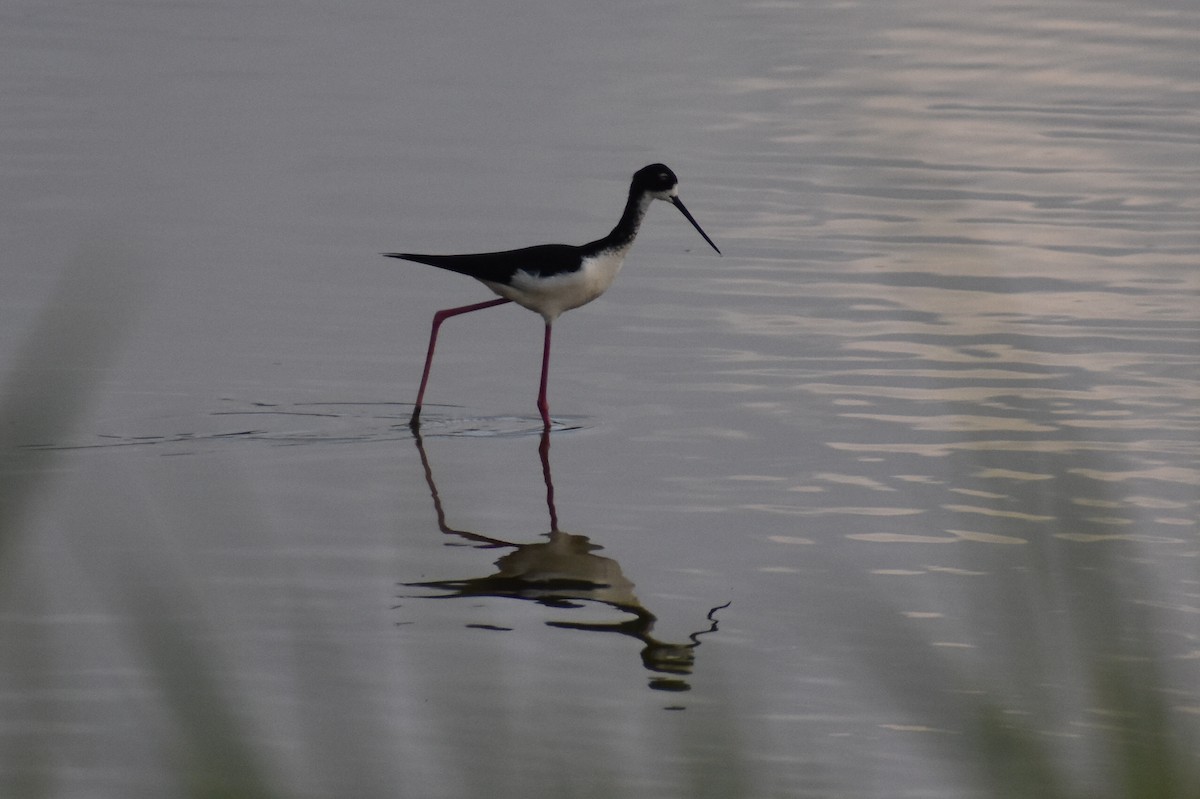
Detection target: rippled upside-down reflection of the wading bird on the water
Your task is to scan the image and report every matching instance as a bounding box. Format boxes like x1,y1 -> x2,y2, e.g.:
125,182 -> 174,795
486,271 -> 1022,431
404,431 -> 728,691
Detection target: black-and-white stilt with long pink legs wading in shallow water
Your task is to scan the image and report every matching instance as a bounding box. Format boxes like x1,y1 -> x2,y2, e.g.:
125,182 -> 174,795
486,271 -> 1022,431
383,163 -> 721,428
